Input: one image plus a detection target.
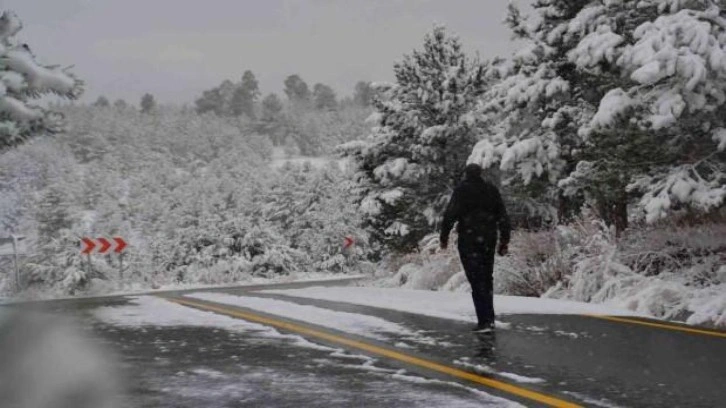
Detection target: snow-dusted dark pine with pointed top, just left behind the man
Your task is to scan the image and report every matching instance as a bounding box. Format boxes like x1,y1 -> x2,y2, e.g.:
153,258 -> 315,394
341,27 -> 485,251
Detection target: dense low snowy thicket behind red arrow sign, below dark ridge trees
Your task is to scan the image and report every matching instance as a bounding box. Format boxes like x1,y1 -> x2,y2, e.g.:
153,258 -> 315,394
0,106 -> 364,293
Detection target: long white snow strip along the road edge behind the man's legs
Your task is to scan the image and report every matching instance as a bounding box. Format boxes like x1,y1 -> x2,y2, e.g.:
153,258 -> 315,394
262,286 -> 642,322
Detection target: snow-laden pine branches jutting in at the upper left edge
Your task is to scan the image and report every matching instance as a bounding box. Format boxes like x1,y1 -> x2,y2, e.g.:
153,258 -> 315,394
0,11 -> 83,149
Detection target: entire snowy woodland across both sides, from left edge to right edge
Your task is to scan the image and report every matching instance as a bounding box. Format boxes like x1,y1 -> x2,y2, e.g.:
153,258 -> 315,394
0,0 -> 726,324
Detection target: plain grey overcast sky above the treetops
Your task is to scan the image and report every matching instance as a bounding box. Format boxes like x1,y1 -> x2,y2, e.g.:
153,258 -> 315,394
5,0 -> 528,103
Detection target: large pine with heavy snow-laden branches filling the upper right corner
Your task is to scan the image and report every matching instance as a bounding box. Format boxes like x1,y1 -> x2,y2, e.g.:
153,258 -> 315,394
470,0 -> 726,229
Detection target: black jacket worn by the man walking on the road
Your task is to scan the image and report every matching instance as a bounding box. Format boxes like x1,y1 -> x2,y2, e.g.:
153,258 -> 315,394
441,174 -> 511,246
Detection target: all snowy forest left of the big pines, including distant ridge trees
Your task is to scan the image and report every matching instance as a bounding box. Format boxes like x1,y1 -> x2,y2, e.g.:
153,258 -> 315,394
0,8 -> 370,293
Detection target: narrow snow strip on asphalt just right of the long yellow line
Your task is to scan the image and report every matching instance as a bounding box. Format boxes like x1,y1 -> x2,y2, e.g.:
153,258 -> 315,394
185,288 -> 444,344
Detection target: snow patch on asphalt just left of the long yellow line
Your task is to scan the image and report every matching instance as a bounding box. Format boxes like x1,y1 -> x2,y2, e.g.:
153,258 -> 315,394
93,296 -> 335,351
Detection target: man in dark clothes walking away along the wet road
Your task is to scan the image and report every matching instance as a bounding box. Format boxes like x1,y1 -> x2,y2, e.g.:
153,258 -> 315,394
439,164 -> 511,331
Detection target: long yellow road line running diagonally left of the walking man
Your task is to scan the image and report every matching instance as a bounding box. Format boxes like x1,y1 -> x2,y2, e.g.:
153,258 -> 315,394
164,297 -> 581,408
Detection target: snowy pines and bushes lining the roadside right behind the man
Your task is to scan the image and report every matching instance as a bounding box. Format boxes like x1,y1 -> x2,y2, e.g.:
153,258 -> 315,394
341,0 -> 726,325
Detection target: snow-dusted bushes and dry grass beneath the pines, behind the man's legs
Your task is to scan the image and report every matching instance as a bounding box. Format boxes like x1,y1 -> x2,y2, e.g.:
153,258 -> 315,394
371,217 -> 726,327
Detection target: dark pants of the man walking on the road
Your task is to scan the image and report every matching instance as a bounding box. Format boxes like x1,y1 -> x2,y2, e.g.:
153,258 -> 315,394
459,237 -> 497,325
